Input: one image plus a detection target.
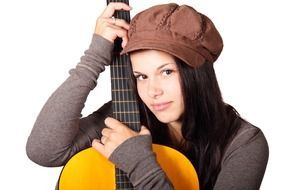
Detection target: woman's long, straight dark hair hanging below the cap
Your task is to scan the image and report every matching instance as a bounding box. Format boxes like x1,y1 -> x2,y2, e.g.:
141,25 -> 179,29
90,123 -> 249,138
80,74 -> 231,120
129,59 -> 242,189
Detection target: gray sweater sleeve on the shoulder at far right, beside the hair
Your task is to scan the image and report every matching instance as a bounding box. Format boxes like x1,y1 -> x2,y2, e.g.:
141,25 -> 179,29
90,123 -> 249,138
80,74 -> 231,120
214,126 -> 269,190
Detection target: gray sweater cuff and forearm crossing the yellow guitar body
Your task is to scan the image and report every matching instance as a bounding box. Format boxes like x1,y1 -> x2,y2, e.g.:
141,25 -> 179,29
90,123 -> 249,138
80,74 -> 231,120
109,135 -> 173,190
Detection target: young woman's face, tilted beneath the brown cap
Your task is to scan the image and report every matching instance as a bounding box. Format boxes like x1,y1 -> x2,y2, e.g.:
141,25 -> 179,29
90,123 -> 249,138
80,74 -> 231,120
130,50 -> 184,125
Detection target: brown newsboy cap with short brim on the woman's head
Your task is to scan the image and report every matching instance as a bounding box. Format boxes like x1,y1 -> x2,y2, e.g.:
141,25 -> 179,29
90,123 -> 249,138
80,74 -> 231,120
122,3 -> 223,67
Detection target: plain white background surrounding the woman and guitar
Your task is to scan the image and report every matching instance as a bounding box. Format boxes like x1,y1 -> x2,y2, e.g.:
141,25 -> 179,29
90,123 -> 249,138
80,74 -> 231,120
0,0 -> 285,190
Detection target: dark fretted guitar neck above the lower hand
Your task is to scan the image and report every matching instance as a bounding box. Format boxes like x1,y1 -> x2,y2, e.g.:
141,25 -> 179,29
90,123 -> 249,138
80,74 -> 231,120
108,0 -> 140,131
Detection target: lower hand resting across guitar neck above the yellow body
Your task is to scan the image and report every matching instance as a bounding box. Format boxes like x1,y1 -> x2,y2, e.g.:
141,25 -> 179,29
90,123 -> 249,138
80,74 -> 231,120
92,117 -> 150,158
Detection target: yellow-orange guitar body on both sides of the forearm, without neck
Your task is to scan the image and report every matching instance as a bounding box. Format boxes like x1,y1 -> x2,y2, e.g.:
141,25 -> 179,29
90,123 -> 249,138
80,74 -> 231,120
59,144 -> 199,190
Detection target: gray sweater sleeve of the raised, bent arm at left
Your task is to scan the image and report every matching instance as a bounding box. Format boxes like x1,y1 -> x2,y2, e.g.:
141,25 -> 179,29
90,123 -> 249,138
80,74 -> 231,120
26,34 -> 113,166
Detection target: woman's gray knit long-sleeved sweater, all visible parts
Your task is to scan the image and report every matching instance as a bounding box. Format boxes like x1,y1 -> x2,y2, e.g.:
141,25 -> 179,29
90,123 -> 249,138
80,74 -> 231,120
26,34 -> 269,190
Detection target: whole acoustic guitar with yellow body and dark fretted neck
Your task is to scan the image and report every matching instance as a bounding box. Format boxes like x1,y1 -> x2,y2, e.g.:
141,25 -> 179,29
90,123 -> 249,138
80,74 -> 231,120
59,0 -> 199,190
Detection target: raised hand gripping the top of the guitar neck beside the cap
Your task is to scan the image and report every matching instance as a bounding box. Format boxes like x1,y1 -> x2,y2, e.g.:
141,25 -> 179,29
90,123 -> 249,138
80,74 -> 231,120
95,2 -> 131,48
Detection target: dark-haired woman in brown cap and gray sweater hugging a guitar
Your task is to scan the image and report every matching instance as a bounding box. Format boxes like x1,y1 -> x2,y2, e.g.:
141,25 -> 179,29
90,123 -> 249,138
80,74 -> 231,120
27,3 -> 268,190
